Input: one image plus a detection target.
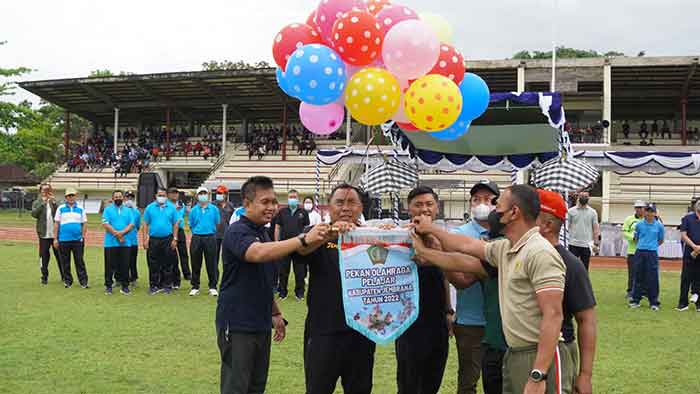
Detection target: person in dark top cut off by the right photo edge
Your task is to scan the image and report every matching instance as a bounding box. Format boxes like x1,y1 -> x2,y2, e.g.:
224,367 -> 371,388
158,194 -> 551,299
676,201 -> 700,312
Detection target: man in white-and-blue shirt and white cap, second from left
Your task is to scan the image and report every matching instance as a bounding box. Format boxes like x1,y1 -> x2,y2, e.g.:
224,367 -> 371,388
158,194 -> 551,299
53,187 -> 89,289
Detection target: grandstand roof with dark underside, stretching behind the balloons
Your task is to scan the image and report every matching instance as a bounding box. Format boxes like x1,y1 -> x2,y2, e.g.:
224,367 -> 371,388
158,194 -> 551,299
19,57 -> 700,125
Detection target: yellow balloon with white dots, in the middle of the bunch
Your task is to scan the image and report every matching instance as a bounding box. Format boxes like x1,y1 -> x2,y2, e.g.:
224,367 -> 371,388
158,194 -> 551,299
345,67 -> 401,126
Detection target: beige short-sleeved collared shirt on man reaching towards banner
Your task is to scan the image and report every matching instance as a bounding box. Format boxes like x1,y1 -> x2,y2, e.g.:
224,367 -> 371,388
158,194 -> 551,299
486,227 -> 566,348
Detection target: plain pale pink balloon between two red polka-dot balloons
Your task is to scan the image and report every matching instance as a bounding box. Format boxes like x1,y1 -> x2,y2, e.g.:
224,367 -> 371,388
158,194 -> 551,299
382,20 -> 440,79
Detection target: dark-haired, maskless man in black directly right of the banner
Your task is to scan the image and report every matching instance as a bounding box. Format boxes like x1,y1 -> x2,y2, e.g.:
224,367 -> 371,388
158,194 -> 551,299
396,186 -> 449,394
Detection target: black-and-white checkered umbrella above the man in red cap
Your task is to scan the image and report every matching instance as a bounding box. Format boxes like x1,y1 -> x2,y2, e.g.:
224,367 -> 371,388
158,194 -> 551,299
533,157 -> 599,193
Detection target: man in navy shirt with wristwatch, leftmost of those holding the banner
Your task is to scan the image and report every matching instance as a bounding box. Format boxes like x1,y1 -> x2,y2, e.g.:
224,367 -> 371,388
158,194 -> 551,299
216,177 -> 328,394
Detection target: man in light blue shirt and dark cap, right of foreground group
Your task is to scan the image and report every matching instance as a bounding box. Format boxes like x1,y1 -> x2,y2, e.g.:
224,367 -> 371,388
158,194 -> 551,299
629,204 -> 664,311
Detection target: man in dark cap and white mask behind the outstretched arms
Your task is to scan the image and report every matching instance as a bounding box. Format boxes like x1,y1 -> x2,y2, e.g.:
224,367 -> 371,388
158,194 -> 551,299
445,180 -> 500,394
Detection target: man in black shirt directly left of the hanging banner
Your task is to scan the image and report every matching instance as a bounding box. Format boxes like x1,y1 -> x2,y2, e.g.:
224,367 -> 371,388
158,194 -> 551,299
298,184 -> 375,394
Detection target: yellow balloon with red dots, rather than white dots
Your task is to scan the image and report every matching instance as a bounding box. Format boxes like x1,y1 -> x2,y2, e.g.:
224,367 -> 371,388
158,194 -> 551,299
404,74 -> 462,132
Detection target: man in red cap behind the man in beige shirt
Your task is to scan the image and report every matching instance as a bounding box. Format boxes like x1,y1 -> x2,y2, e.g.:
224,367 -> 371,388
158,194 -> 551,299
537,189 -> 596,394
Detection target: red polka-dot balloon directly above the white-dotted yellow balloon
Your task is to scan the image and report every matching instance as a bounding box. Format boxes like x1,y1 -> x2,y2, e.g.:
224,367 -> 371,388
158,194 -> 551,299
331,10 -> 384,66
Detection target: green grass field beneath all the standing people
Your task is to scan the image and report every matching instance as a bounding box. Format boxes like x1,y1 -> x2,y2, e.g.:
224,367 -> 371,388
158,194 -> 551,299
0,241 -> 700,394
